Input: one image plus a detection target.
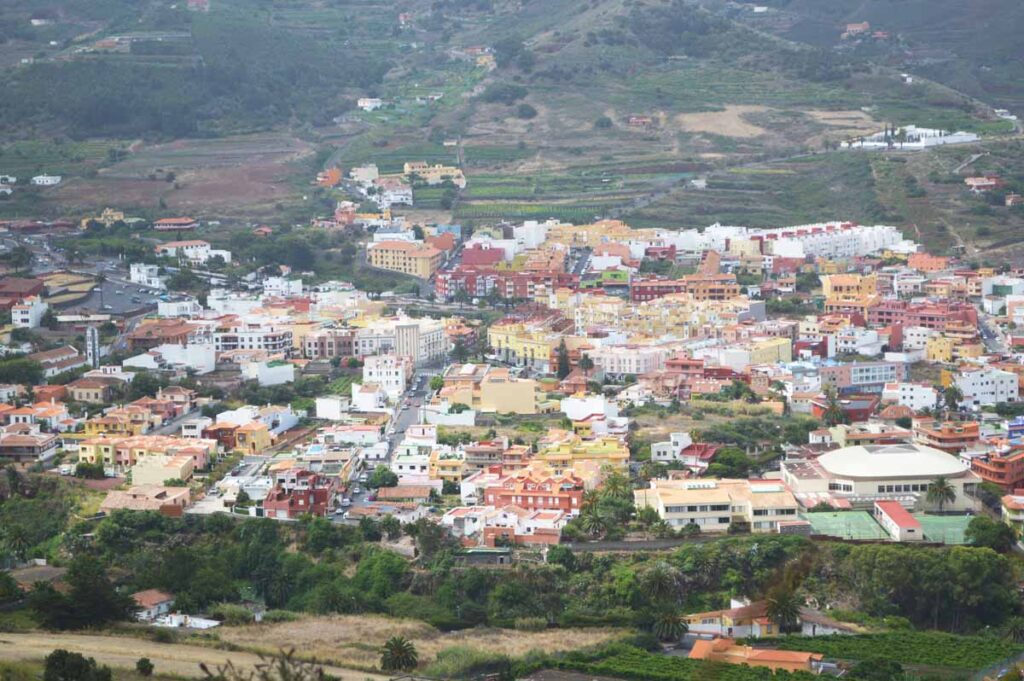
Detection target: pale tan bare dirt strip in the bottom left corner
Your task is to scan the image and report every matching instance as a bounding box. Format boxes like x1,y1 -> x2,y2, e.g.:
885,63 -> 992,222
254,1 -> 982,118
0,633 -> 389,681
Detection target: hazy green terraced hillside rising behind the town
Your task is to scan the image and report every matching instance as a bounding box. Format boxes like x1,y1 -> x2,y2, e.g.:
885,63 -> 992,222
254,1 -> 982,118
0,0 -> 1013,251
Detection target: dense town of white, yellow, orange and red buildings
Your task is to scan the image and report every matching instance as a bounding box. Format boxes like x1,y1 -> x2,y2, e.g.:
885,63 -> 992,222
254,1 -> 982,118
0,199 -> 1024,673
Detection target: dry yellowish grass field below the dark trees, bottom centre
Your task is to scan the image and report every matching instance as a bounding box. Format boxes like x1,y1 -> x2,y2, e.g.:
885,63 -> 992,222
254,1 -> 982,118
220,614 -> 628,669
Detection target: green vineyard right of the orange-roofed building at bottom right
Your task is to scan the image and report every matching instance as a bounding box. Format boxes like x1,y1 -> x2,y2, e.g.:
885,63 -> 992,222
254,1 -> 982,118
777,631 -> 1024,670
